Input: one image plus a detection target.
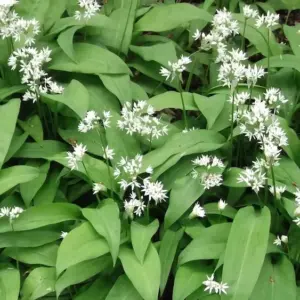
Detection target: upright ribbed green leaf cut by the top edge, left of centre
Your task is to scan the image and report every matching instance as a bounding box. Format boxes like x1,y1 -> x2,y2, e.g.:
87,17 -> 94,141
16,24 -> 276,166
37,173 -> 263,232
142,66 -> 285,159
99,0 -> 139,55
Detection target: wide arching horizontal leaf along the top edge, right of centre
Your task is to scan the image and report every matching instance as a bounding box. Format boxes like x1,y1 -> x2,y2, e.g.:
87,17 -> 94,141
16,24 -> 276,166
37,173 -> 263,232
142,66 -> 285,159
134,3 -> 212,32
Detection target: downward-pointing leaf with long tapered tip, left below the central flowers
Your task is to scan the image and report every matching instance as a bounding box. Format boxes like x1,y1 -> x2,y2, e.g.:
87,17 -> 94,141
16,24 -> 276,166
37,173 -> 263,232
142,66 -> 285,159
82,199 -> 121,265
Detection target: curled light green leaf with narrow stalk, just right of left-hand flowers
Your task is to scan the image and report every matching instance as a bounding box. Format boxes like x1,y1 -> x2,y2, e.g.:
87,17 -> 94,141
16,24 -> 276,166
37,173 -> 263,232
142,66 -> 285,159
42,80 -> 89,118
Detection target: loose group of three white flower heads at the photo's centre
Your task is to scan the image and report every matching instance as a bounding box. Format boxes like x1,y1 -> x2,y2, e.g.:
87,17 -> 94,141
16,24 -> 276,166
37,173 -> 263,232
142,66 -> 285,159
114,154 -> 167,216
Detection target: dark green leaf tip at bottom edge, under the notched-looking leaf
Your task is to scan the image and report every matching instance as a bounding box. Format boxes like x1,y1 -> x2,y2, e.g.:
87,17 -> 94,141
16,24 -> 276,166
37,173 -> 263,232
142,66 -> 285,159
105,275 -> 143,300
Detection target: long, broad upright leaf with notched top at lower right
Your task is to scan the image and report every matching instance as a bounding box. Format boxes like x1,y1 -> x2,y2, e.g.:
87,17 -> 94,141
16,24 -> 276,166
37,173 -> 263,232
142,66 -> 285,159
222,206 -> 271,300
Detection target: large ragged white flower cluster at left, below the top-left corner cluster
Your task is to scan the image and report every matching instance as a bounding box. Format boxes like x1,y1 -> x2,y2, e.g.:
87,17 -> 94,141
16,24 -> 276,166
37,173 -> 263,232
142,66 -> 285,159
8,47 -> 64,102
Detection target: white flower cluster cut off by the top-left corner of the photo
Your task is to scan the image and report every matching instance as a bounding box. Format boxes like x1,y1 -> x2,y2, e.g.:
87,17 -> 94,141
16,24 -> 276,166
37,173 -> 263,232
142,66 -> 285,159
0,0 -> 40,46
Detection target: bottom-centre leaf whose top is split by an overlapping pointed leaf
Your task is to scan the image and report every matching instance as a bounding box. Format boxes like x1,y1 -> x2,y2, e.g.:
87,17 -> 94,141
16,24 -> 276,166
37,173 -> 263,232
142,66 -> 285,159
119,244 -> 161,300
